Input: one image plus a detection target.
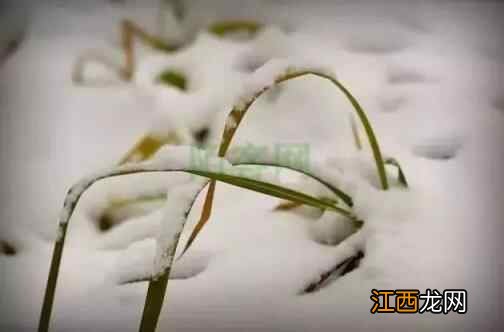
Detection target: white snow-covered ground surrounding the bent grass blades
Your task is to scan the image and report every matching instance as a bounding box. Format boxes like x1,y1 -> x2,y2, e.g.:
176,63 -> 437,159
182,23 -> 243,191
0,0 -> 504,331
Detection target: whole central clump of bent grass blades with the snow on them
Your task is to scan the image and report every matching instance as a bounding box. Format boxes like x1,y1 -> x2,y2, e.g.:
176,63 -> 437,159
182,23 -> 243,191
39,60 -> 407,332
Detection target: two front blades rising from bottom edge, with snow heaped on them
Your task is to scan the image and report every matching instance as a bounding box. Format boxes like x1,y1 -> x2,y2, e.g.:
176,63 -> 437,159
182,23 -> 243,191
39,147 -> 359,331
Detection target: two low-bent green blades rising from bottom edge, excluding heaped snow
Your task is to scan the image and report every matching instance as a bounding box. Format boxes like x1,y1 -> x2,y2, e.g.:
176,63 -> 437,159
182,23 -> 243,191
38,158 -> 359,332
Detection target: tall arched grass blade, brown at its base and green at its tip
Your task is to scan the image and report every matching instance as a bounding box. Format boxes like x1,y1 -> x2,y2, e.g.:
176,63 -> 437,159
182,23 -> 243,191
182,68 -> 389,254
